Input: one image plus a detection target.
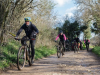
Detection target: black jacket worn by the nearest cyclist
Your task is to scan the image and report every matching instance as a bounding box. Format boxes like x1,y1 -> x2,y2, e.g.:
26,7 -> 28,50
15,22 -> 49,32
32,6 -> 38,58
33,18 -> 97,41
16,22 -> 39,37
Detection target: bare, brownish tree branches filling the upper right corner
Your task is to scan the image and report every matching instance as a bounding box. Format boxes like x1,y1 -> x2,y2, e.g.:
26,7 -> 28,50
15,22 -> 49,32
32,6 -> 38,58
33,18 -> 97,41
75,0 -> 100,34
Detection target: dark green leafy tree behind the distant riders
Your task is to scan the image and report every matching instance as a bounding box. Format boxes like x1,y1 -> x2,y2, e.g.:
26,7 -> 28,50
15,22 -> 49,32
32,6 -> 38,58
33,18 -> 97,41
56,20 -> 87,40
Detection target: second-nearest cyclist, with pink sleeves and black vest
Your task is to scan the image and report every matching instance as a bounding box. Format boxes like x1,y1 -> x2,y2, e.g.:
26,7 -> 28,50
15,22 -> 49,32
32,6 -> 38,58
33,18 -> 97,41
55,31 -> 66,55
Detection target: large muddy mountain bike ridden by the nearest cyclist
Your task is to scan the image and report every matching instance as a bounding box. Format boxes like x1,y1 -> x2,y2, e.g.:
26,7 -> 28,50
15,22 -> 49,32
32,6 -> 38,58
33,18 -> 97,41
15,38 -> 35,70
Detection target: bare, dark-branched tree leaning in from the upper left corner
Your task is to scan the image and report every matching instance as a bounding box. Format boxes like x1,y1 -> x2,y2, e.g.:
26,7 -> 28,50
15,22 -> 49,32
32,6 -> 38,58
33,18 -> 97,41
0,0 -> 38,44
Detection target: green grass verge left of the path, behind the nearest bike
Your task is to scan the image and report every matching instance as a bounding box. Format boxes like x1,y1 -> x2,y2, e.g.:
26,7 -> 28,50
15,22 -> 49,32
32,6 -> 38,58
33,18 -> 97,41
0,41 -> 56,69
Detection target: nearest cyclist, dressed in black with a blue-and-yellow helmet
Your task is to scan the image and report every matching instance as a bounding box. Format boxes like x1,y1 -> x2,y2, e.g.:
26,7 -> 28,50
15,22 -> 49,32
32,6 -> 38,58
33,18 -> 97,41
15,17 -> 39,63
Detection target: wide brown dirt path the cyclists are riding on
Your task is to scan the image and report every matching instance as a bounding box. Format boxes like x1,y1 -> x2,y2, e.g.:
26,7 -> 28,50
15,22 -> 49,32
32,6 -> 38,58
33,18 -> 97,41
1,51 -> 100,75
